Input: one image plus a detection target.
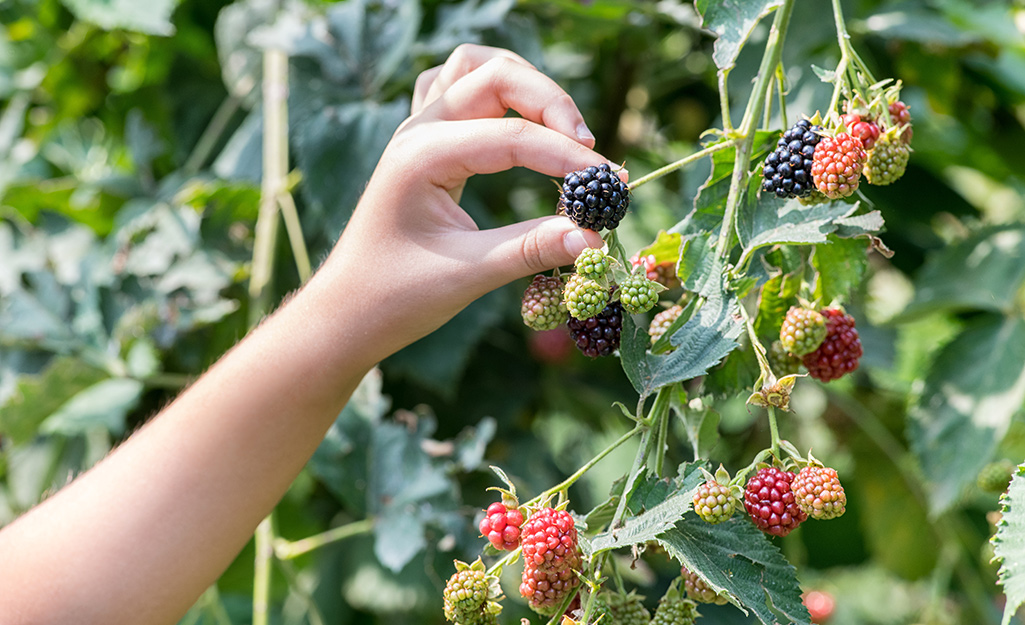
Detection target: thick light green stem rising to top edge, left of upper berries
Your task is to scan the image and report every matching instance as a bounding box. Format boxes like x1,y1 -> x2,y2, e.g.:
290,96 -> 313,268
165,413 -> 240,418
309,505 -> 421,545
715,0 -> 794,260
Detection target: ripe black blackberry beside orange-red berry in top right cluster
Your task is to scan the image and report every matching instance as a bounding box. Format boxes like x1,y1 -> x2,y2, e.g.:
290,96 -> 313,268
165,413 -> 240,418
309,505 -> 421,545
762,119 -> 822,199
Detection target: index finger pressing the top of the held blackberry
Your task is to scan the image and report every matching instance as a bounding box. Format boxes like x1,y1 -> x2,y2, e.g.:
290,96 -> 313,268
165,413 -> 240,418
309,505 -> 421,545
396,118 -> 611,184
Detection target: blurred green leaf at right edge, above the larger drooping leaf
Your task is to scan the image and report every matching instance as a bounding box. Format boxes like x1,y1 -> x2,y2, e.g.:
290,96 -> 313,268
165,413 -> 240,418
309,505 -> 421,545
900,223 -> 1025,319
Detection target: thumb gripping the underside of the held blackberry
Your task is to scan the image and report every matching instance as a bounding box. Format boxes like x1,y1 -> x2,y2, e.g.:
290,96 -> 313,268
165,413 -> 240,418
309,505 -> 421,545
475,216 -> 604,290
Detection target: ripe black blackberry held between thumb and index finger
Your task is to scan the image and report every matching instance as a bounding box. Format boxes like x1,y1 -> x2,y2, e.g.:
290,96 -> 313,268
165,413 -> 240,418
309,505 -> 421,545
559,163 -> 630,233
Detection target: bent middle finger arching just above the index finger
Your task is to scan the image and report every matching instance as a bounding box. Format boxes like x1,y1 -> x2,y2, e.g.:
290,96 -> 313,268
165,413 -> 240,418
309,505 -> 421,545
421,57 -> 595,147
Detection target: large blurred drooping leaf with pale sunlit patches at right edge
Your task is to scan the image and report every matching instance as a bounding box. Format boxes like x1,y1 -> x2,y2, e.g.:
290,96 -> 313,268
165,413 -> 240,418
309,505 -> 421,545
908,315 -> 1025,514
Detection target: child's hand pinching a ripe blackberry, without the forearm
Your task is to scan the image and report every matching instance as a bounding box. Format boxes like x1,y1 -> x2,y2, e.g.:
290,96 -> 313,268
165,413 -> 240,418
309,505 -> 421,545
314,45 -> 607,360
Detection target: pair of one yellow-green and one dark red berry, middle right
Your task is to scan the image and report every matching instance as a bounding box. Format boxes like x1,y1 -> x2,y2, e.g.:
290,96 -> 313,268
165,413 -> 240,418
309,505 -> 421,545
769,306 -> 863,382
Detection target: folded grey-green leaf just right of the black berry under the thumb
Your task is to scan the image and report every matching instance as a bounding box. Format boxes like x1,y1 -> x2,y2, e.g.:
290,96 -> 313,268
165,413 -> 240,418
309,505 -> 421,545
620,280 -> 743,398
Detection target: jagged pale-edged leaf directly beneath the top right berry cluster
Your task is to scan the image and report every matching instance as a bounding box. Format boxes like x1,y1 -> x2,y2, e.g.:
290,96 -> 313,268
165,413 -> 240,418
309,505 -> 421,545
737,194 -> 858,257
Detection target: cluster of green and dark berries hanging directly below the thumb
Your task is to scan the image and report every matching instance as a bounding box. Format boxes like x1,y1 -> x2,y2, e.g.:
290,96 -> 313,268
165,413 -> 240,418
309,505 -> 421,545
520,248 -> 664,358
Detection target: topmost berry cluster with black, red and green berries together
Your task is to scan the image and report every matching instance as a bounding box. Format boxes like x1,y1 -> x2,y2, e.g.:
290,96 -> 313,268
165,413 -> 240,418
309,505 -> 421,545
762,100 -> 911,199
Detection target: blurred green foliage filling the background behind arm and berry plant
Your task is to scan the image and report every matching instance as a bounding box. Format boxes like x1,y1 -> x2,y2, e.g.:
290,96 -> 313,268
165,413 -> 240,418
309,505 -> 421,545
0,0 -> 1025,625
